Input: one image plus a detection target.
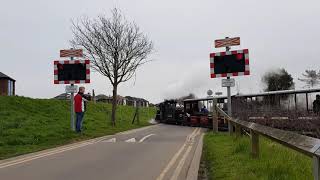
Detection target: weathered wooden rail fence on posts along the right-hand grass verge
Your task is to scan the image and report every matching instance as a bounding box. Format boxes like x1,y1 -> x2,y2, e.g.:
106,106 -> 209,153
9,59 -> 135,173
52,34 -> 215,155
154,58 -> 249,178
213,106 -> 320,180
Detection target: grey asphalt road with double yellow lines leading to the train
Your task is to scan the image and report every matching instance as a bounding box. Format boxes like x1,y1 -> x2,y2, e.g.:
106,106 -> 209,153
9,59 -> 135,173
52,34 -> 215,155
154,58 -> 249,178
0,124 -> 203,180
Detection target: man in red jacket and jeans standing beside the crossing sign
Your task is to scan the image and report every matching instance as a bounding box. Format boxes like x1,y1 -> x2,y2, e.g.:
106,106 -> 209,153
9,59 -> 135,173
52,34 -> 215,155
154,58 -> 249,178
74,87 -> 87,133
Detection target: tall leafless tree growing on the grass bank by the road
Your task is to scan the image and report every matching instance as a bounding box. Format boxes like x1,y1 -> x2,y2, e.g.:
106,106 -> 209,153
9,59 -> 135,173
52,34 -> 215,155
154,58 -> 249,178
70,8 -> 153,126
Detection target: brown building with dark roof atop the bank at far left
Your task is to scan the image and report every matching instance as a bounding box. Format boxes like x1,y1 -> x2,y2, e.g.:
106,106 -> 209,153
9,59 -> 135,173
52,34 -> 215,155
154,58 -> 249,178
0,72 -> 16,96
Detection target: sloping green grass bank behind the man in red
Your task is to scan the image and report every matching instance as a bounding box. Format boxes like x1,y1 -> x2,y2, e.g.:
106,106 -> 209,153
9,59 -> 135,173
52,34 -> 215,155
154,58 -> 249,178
0,96 -> 155,159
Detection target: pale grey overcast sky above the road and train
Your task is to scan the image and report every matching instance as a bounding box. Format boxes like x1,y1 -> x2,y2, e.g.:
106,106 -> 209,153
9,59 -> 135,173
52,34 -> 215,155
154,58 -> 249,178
0,0 -> 320,103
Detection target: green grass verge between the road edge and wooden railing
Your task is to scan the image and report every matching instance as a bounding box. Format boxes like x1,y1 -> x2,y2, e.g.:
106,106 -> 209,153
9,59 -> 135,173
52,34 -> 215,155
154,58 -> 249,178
203,133 -> 313,180
